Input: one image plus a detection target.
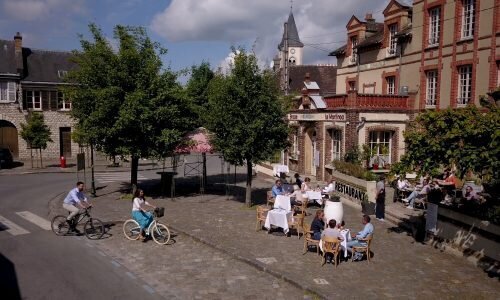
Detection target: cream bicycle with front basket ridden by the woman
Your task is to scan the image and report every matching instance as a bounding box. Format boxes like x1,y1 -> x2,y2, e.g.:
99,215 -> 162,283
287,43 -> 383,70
123,207 -> 170,245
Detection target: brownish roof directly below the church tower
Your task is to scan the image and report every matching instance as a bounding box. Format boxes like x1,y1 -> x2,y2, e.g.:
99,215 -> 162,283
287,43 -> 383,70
289,65 -> 337,95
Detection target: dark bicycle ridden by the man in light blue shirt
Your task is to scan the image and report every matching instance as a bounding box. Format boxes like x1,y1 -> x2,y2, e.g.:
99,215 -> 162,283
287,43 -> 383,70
51,207 -> 104,240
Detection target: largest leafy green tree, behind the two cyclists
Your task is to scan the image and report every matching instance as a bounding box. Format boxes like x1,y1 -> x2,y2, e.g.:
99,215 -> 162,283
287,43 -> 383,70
66,24 -> 194,188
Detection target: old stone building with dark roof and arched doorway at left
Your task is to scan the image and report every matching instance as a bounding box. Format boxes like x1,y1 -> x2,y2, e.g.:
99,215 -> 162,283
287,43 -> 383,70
0,33 -> 78,159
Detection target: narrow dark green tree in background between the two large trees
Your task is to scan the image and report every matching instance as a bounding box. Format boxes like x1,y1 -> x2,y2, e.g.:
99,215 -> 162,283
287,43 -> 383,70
186,62 -> 215,126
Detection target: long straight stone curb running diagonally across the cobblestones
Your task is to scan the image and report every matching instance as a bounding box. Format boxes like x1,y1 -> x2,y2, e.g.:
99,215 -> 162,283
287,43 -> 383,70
168,225 -> 329,299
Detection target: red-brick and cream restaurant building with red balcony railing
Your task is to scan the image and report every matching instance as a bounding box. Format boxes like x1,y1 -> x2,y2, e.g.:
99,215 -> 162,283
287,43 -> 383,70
285,0 -> 500,180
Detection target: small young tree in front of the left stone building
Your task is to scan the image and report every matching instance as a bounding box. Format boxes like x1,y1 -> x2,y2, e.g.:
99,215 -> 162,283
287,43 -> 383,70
20,112 -> 52,168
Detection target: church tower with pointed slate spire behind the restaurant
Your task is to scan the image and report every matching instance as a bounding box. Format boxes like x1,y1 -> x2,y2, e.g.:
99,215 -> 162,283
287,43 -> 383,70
278,10 -> 304,68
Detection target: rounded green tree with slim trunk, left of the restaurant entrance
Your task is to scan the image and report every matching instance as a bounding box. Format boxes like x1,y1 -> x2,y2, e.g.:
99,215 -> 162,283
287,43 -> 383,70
206,49 -> 288,206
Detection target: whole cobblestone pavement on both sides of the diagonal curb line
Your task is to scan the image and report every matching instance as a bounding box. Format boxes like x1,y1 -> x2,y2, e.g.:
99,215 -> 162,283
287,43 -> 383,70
47,179 -> 500,299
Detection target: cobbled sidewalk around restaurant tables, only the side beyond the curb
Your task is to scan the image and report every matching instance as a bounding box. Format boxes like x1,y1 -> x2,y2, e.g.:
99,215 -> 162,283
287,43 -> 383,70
47,175 -> 500,299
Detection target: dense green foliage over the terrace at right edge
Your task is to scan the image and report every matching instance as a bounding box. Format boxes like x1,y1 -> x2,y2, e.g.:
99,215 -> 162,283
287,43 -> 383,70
395,99 -> 500,179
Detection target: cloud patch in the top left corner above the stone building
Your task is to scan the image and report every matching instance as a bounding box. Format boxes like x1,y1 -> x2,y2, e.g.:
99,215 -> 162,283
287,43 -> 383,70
2,0 -> 85,21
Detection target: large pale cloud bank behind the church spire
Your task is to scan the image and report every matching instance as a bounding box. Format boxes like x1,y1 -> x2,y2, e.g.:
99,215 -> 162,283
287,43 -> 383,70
150,0 -> 389,63
